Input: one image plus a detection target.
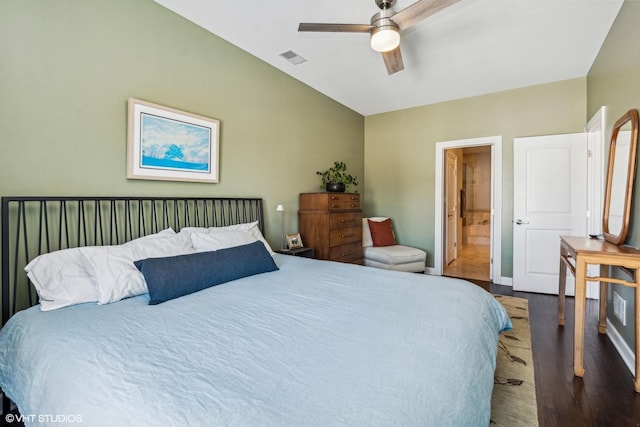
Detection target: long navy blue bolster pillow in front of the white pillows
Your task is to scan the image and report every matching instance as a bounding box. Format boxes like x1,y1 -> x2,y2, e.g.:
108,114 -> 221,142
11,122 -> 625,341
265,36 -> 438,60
134,241 -> 278,305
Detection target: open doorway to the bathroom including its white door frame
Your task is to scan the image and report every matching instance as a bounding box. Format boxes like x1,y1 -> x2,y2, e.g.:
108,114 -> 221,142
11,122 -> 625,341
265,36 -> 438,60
433,136 -> 502,283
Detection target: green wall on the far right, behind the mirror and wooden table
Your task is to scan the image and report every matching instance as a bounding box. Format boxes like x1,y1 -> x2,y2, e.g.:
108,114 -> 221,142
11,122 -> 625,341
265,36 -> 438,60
587,1 -> 640,348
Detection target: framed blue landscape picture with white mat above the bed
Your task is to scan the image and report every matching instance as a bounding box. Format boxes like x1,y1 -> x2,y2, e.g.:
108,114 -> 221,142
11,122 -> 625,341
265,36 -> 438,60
127,98 -> 220,183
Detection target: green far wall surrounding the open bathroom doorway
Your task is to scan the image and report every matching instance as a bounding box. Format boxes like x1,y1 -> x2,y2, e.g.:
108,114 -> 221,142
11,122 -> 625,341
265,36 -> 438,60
364,78 -> 586,277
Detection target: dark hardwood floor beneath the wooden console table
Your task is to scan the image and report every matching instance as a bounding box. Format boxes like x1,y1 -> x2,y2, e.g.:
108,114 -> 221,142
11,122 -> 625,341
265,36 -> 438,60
492,285 -> 640,427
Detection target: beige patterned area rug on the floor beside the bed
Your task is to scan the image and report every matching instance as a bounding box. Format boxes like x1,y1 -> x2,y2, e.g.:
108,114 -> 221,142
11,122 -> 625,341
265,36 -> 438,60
491,295 -> 538,427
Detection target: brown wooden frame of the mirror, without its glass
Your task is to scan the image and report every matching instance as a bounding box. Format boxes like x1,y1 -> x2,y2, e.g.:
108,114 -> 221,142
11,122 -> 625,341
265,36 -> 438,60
602,110 -> 638,245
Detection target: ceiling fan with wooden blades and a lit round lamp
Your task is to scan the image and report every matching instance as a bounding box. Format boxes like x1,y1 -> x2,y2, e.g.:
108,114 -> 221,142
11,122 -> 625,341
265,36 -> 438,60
298,0 -> 460,75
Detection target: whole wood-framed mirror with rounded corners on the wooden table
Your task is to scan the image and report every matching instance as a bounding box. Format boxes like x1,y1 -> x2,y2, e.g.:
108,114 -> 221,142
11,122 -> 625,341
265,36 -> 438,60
602,110 -> 638,245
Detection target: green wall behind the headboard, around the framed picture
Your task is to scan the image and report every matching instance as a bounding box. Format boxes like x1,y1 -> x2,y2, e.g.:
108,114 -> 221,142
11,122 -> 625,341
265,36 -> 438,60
0,0 -> 364,245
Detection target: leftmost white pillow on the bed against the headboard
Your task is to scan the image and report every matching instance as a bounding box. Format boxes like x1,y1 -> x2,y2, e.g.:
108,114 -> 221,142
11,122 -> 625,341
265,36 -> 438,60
24,248 -> 98,311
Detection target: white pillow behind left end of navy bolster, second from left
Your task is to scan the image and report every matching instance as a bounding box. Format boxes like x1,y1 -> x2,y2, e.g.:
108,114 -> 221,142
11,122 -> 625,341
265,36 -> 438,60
78,228 -> 192,304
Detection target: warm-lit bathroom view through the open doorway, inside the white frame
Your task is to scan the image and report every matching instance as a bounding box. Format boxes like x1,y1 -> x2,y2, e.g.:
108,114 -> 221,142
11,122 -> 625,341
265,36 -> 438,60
443,145 -> 492,282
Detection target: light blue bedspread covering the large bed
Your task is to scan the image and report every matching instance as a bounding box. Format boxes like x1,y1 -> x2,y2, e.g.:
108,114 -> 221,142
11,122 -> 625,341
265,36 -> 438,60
0,254 -> 510,427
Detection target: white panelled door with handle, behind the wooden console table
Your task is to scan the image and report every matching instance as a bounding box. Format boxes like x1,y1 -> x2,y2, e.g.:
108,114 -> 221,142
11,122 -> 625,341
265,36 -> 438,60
513,133 -> 587,295
